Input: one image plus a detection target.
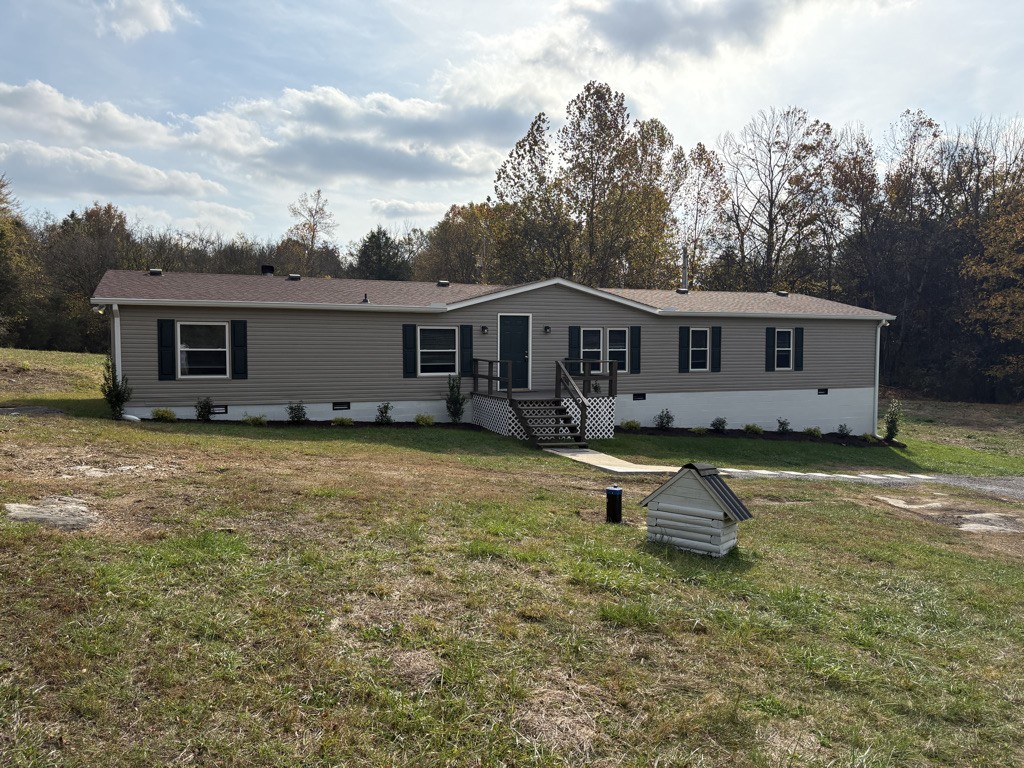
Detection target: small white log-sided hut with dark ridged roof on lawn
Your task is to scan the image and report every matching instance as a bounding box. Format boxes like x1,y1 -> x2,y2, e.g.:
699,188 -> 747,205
640,464 -> 753,557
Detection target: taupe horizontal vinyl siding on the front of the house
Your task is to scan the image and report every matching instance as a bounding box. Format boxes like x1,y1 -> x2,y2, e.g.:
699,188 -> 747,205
121,286 -> 878,407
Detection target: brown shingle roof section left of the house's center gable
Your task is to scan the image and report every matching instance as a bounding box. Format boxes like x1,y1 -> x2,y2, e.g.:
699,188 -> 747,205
93,269 -> 502,307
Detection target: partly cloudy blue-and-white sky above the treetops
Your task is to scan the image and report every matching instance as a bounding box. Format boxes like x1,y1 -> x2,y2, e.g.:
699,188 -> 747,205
0,0 -> 1024,246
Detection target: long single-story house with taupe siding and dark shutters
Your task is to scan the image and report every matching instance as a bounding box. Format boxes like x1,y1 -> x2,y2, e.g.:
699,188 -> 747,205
92,268 -> 894,440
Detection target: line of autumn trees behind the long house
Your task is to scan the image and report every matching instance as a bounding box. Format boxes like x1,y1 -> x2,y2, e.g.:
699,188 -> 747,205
0,82 -> 1024,400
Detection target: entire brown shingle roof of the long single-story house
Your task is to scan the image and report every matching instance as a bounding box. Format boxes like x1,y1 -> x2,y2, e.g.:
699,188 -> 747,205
93,269 -> 893,319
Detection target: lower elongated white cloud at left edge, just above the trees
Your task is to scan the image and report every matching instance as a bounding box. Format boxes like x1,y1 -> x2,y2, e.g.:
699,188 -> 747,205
0,141 -> 226,198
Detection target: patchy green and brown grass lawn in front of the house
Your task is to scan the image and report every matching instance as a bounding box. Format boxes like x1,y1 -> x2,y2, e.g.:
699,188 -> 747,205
0,350 -> 1024,766
